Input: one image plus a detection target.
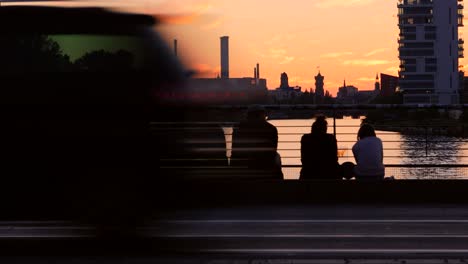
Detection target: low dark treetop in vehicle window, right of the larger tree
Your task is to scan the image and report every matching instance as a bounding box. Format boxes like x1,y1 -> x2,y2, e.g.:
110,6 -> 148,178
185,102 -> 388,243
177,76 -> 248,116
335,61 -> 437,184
75,50 -> 134,72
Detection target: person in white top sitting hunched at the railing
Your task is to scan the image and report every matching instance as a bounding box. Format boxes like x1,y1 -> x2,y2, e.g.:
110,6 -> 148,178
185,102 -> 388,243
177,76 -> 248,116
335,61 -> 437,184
353,124 -> 385,180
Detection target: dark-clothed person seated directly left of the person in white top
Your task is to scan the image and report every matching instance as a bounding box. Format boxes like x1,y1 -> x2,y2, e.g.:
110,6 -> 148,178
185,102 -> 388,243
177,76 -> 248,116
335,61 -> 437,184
300,116 -> 342,180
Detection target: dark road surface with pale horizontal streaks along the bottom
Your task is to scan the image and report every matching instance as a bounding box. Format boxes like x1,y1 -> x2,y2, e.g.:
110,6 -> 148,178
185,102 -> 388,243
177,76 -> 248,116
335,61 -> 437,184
0,204 -> 468,263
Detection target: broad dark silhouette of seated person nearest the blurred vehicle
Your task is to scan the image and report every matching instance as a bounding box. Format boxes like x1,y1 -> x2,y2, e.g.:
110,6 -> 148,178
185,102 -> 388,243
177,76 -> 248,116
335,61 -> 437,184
231,106 -> 283,179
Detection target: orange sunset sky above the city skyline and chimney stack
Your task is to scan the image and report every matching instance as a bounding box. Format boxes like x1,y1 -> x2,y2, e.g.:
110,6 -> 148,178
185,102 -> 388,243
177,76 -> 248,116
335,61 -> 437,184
6,0 -> 466,96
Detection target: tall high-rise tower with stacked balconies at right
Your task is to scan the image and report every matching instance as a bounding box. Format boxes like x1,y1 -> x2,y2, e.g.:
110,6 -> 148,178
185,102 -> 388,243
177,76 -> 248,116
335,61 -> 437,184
398,0 -> 463,104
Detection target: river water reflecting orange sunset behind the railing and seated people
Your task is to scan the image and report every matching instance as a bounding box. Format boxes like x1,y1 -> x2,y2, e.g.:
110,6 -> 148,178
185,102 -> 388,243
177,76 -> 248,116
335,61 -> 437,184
269,117 -> 468,179
